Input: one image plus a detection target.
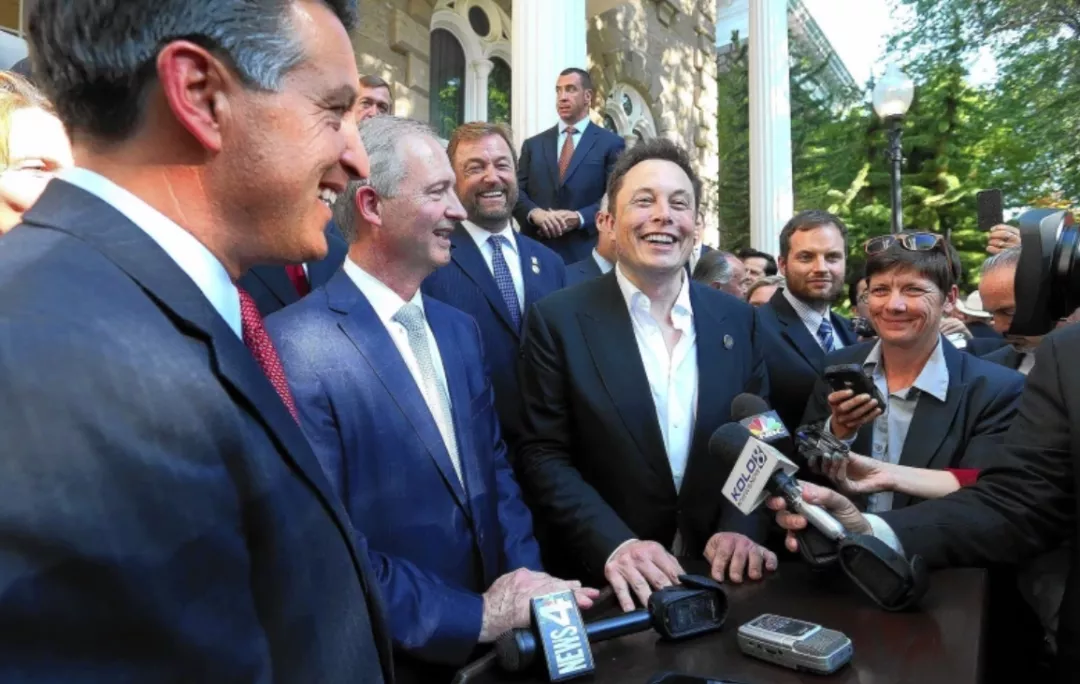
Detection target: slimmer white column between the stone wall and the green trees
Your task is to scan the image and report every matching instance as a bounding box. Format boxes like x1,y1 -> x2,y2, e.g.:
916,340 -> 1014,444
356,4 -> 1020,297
747,0 -> 795,254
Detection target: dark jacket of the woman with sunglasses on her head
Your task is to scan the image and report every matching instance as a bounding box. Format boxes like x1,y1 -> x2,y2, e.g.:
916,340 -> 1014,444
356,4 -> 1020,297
805,337 -> 1024,508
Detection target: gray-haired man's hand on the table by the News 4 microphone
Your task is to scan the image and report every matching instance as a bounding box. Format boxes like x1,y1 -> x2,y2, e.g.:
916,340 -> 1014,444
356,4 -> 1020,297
480,568 -> 599,644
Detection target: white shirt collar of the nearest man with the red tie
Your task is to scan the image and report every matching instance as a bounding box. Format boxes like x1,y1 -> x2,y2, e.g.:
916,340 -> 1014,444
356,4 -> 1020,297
57,169 -> 243,339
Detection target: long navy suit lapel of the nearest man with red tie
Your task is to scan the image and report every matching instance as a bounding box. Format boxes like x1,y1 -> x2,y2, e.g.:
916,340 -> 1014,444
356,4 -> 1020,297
27,180 -> 363,566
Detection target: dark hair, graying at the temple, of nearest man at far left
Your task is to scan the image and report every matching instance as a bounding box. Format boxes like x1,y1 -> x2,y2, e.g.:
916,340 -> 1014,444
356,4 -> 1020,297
27,0 -> 357,142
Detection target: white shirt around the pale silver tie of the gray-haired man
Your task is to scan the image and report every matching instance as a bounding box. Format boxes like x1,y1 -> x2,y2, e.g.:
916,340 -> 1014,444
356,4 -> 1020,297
343,258 -> 461,468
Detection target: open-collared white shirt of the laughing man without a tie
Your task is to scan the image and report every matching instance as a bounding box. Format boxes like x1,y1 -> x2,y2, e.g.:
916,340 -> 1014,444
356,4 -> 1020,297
615,265 -> 698,492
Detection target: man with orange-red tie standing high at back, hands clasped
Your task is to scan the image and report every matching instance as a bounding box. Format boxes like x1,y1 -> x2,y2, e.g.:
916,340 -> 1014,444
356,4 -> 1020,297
514,69 -> 626,264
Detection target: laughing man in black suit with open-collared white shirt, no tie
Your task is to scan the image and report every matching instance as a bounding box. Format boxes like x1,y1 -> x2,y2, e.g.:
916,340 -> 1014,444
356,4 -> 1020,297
516,139 -> 777,611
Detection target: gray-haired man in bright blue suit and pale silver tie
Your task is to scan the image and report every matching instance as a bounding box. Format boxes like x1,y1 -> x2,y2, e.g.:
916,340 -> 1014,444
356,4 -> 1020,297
267,117 -> 596,684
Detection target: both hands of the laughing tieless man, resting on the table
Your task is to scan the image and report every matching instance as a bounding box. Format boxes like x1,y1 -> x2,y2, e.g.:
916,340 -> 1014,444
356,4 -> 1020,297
604,532 -> 777,612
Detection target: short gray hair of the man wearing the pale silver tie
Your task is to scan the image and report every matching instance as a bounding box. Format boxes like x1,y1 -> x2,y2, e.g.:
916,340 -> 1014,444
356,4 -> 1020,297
334,116 -> 438,243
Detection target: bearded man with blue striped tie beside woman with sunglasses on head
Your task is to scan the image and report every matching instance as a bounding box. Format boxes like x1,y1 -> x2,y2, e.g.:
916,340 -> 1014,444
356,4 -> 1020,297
758,210 -> 855,432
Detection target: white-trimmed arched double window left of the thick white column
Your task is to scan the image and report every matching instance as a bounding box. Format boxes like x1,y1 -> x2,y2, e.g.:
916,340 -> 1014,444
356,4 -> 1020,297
431,0 -> 511,126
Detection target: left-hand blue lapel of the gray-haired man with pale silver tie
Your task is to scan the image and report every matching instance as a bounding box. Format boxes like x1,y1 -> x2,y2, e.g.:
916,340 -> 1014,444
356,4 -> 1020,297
326,270 -> 469,511
